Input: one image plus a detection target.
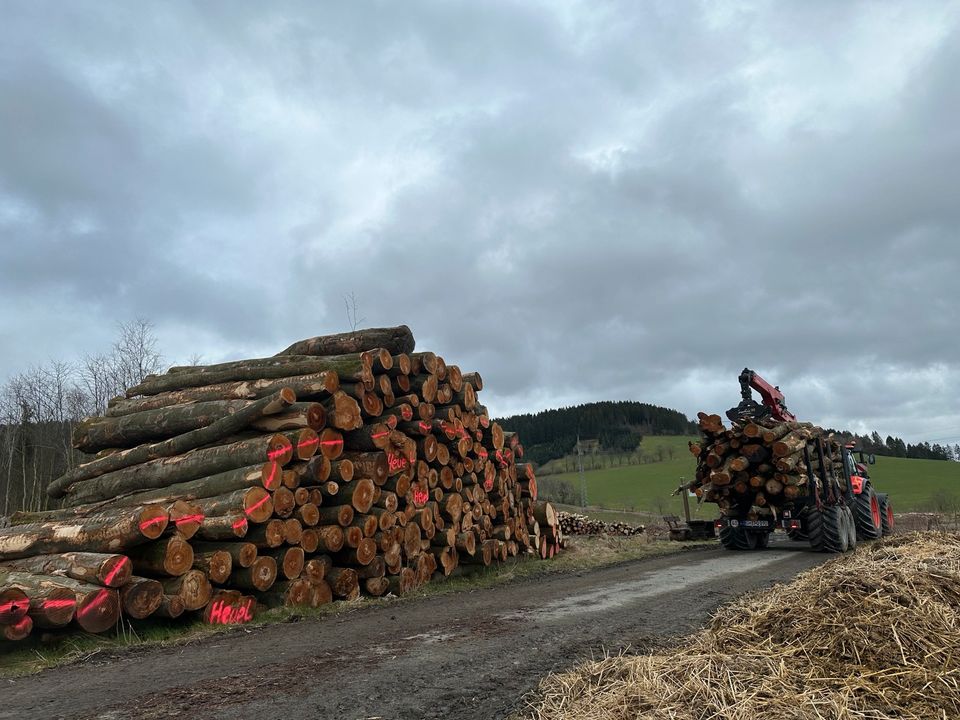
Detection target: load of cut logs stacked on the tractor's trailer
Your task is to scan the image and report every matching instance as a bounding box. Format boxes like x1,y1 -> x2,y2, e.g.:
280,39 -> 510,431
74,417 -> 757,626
690,413 -> 841,519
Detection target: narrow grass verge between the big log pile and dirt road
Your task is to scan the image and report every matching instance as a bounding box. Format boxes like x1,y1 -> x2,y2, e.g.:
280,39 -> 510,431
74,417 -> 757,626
0,535 -> 713,678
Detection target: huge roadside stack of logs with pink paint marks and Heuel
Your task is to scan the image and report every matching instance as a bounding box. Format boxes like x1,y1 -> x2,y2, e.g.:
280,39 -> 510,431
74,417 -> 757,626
0,326 -> 561,640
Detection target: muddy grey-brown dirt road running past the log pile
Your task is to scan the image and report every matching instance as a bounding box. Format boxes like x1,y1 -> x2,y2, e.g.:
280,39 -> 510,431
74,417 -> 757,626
0,544 -> 827,720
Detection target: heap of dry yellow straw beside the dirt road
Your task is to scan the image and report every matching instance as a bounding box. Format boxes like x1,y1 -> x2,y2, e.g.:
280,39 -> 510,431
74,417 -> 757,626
524,533 -> 960,720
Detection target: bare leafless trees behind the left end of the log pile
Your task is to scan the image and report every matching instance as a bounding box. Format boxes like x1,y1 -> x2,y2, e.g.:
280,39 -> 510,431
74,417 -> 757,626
0,320 -> 161,517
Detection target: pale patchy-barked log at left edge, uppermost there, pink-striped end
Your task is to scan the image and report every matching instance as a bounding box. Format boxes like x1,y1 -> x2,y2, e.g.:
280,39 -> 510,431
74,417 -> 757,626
0,505 -> 168,561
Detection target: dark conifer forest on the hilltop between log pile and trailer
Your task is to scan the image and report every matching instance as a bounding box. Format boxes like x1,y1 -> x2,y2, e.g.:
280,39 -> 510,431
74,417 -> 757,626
497,401 -> 697,465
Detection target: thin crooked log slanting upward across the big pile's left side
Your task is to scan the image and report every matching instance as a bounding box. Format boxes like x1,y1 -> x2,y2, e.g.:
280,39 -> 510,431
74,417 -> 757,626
47,388 -> 297,498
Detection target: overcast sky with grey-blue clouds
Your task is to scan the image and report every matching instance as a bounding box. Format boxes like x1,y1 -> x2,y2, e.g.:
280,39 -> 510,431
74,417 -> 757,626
0,0 -> 960,443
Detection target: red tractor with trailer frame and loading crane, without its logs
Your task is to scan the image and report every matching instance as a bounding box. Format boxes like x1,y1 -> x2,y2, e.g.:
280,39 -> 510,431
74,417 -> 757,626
715,368 -> 894,553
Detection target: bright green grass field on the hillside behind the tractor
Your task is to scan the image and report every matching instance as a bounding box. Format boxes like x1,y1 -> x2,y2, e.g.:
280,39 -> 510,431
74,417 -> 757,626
547,437 -> 960,519
